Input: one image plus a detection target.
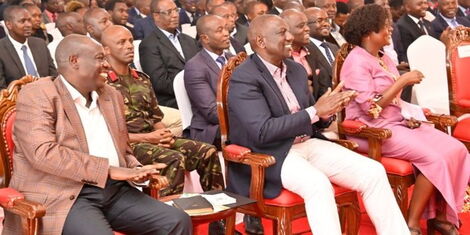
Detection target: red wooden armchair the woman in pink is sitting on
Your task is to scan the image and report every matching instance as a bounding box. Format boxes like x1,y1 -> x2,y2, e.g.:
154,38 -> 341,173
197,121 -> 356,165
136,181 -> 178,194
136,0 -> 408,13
333,43 -> 457,219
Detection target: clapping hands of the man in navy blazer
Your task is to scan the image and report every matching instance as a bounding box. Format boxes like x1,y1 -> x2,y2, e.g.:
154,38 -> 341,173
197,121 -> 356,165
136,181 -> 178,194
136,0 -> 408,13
313,82 -> 357,119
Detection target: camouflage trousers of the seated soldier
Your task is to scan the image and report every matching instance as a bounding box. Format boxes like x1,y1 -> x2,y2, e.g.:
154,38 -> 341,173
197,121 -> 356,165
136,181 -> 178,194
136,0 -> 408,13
132,138 -> 225,196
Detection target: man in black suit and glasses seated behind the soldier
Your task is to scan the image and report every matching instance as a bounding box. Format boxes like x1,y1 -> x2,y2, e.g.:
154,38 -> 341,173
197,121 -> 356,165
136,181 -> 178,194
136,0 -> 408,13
139,0 -> 199,108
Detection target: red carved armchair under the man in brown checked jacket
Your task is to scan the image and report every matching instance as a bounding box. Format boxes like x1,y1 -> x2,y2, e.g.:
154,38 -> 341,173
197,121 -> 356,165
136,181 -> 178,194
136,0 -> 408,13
0,75 -> 166,235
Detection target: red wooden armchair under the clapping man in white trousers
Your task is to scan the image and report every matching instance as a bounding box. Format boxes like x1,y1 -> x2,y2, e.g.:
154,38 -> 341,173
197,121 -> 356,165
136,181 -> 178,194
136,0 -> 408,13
217,52 -> 360,234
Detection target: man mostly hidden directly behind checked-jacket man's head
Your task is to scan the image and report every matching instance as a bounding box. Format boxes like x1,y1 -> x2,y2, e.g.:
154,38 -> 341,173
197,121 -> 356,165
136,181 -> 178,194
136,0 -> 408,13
47,12 -> 86,66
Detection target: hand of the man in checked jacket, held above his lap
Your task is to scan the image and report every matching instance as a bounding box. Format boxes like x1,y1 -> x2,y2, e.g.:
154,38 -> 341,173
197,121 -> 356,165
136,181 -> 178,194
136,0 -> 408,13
109,164 -> 166,183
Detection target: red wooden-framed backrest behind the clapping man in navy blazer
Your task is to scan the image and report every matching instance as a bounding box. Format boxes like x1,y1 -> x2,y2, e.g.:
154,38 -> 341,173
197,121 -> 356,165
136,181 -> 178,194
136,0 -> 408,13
217,52 -> 246,148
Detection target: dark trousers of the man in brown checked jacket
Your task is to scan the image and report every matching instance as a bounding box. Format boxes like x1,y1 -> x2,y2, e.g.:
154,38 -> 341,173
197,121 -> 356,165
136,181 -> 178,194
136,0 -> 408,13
62,179 -> 192,235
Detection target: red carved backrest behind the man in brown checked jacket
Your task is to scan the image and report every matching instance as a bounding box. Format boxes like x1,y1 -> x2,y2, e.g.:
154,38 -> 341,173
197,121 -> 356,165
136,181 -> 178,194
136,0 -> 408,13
0,75 -> 38,187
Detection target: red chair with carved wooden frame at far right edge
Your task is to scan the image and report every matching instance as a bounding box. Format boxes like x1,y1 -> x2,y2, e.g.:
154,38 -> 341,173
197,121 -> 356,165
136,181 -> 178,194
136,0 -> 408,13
447,27 -> 470,149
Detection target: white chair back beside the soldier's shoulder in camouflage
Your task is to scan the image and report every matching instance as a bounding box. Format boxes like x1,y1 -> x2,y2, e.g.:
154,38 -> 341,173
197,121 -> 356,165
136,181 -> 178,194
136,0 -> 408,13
173,70 -> 193,130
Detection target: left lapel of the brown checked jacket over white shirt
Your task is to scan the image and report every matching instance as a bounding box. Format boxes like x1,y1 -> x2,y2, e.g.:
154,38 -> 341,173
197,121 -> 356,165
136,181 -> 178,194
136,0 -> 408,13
54,77 -> 89,153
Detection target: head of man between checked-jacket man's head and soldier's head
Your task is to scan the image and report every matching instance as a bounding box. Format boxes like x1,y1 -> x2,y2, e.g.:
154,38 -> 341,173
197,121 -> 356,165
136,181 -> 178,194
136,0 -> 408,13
83,8 -> 113,43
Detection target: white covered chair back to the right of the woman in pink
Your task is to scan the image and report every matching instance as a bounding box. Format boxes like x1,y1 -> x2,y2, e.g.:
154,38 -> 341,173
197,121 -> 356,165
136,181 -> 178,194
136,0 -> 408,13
407,35 -> 450,114
